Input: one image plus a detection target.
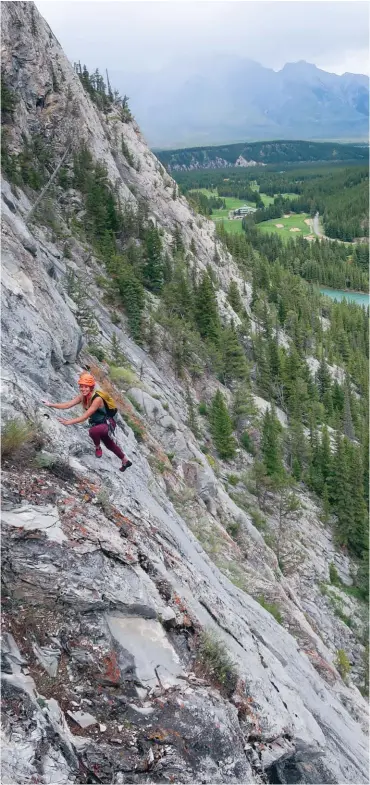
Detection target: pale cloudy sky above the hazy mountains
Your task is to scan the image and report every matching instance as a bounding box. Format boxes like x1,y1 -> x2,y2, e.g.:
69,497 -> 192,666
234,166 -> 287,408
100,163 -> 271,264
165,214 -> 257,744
36,0 -> 369,74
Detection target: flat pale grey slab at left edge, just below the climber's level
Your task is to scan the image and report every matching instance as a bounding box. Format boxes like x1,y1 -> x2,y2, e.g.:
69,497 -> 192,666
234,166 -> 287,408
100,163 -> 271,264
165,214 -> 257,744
2,504 -> 68,543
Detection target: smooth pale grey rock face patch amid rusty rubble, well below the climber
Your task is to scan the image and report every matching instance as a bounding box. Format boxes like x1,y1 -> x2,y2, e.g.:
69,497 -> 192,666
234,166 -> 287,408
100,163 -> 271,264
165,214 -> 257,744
107,614 -> 183,687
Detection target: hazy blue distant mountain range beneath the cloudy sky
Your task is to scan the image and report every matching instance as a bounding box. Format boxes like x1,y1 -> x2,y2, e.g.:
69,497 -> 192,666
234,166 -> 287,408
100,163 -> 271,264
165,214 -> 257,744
115,55 -> 369,148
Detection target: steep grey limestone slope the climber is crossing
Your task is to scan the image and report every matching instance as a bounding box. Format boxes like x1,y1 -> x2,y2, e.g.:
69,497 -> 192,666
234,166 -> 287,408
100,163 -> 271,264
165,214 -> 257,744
1,2 -> 368,783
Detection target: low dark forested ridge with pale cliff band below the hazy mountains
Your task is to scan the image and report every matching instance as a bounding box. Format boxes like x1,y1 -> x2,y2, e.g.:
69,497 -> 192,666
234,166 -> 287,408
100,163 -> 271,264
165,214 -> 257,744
157,140 -> 368,171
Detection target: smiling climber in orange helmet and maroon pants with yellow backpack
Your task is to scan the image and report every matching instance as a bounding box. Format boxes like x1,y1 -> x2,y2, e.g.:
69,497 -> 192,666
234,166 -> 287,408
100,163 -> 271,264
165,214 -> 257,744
42,373 -> 132,472
